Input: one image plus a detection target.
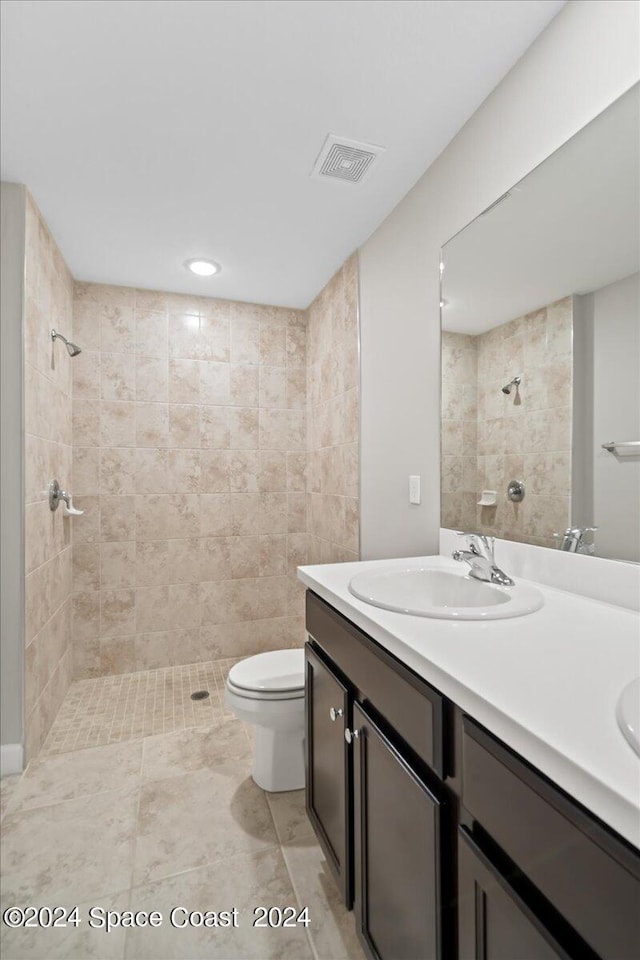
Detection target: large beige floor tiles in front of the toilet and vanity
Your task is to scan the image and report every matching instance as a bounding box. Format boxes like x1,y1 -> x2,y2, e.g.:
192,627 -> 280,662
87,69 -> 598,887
1,663 -> 362,960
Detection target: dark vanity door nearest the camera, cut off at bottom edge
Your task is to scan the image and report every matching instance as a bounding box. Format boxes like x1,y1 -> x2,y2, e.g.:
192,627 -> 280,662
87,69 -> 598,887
458,827 -> 569,960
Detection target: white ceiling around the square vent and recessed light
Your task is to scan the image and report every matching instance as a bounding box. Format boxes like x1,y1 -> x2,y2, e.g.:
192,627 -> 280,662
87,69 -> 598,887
2,0 -> 563,307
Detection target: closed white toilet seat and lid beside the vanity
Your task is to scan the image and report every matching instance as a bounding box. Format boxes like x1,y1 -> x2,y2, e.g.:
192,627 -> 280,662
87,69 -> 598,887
227,649 -> 304,700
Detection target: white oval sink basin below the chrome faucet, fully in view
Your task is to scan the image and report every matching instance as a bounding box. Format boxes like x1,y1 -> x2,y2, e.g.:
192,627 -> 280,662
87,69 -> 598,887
349,567 -> 544,620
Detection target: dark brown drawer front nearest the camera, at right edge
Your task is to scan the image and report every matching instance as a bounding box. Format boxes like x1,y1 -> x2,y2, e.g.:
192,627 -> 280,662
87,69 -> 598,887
462,717 -> 640,960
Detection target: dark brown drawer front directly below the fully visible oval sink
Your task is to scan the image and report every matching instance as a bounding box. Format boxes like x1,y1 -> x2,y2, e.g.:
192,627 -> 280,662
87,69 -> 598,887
307,591 -> 444,777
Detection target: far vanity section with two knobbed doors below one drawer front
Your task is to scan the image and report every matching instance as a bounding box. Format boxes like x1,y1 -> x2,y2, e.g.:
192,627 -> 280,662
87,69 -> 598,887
306,594 -> 452,960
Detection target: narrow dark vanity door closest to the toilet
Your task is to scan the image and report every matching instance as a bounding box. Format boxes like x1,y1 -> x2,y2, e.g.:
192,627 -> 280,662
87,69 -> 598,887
305,644 -> 352,907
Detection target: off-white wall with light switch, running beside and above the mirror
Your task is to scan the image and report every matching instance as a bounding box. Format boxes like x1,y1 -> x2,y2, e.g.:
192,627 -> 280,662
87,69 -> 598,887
360,0 -> 640,559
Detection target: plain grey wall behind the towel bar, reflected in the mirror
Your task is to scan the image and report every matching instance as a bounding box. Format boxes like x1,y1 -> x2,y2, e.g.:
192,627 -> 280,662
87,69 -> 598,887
592,273 -> 640,563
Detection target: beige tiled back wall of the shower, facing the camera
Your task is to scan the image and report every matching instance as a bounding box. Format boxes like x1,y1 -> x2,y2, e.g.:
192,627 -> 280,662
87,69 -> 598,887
73,283 -> 307,677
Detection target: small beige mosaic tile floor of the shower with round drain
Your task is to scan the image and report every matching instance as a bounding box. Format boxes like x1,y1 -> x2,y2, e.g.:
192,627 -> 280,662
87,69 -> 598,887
40,660 -> 240,757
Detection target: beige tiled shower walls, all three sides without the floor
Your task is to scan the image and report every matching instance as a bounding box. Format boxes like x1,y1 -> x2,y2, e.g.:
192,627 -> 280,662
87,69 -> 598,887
25,198 -> 359,758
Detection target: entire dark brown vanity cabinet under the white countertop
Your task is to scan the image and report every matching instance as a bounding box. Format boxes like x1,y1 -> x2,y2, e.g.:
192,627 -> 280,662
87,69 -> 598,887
306,592 -> 640,960
